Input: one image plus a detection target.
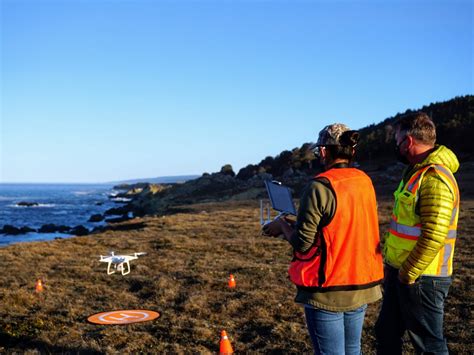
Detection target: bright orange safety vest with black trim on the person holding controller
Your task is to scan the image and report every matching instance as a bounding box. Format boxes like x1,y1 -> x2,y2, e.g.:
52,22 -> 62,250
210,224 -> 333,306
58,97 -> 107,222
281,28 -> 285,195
288,168 -> 383,291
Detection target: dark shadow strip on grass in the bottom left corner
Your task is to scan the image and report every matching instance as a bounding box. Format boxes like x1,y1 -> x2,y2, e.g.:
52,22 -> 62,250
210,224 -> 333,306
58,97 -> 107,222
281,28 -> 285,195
0,331 -> 105,354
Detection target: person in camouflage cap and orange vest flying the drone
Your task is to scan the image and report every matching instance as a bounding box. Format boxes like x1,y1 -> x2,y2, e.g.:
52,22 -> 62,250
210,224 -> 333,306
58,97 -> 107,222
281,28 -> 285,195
263,123 -> 383,354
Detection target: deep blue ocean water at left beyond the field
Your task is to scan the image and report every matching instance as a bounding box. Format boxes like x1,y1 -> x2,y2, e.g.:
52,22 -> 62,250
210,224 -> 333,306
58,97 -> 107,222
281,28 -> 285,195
0,184 -> 123,247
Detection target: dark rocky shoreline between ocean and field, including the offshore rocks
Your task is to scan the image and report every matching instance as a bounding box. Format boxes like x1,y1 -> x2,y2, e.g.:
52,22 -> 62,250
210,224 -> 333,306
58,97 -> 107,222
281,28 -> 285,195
0,163 -> 473,241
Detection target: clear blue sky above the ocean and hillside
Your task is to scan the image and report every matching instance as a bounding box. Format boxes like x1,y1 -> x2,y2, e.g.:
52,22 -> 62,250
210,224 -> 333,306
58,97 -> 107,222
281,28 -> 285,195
0,0 -> 473,182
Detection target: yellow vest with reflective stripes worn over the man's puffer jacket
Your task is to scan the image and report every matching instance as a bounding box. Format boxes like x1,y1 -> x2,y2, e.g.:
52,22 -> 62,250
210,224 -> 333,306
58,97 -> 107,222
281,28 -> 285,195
384,164 -> 459,276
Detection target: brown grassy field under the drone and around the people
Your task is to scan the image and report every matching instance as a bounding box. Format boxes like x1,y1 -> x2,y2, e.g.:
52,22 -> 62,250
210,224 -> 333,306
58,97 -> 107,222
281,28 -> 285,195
0,200 -> 474,354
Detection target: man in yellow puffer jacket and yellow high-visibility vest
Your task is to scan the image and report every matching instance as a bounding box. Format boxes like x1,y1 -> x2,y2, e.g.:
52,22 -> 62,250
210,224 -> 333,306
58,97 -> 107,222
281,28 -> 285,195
375,112 -> 459,354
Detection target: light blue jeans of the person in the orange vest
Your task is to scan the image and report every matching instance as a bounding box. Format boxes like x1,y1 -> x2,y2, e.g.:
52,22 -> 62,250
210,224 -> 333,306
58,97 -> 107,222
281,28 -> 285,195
304,305 -> 367,355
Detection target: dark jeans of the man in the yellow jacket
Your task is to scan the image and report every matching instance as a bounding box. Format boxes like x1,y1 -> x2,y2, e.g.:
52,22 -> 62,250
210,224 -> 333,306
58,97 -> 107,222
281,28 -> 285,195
375,266 -> 451,355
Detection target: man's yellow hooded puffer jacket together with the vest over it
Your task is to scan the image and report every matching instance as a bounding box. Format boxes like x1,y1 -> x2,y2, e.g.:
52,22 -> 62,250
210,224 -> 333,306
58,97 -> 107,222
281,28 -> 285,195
384,146 -> 459,282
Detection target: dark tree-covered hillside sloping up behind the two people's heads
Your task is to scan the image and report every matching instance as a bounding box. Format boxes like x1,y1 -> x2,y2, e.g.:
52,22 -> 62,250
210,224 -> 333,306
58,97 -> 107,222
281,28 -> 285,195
237,95 -> 474,180
